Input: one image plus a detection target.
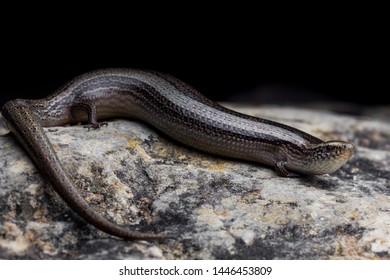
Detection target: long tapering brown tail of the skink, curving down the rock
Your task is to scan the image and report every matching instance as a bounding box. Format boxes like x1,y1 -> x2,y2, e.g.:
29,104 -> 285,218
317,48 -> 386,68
2,99 -> 169,240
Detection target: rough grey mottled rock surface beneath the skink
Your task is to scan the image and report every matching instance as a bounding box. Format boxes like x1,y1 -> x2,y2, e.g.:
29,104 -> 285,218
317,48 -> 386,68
0,106 -> 390,259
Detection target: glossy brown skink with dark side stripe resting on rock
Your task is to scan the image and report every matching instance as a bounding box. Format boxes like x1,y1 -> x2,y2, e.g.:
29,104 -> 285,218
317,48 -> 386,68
2,69 -> 355,240
